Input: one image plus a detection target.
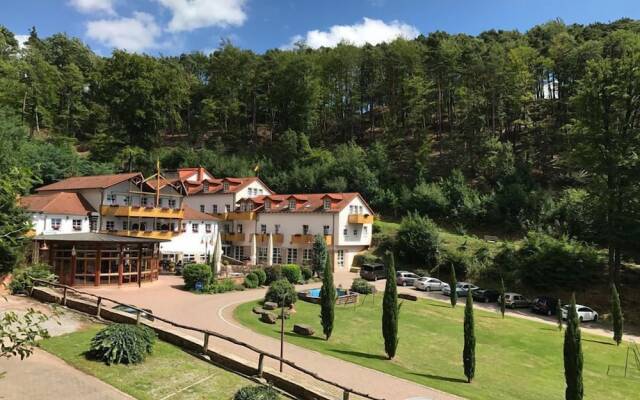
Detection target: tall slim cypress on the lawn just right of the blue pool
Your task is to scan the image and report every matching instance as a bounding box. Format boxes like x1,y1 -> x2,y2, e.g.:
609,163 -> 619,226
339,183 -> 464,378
382,251 -> 400,360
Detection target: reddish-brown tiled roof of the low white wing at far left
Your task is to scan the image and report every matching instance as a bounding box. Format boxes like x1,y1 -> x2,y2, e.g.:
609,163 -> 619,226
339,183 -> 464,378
20,192 -> 96,215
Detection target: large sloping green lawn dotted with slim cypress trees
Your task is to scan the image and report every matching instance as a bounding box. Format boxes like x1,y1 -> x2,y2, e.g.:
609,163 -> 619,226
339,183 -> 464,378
235,295 -> 640,400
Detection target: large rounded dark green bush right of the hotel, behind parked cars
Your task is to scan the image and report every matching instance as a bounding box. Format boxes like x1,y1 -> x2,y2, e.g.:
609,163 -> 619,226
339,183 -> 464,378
396,213 -> 440,268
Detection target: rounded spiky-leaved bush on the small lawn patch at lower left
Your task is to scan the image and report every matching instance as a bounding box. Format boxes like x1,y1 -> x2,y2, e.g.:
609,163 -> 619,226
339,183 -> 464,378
89,324 -> 156,364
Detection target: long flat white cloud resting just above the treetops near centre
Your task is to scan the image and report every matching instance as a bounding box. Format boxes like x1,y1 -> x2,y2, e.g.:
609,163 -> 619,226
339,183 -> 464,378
283,17 -> 420,49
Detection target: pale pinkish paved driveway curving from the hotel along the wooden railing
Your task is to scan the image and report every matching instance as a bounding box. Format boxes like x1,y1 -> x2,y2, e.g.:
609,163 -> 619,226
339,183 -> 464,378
87,273 -> 459,400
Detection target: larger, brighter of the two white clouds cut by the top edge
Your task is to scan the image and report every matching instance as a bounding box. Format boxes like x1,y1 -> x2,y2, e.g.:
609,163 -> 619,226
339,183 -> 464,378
157,0 -> 247,32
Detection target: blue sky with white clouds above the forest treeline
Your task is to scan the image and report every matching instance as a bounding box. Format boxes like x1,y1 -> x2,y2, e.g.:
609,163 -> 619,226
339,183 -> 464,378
0,0 -> 640,55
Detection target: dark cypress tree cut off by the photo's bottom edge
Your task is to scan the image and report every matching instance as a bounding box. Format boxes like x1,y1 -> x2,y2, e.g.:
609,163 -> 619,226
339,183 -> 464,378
564,294 -> 584,400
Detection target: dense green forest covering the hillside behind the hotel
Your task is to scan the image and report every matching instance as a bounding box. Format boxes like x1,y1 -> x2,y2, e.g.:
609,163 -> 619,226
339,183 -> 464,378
0,19 -> 640,288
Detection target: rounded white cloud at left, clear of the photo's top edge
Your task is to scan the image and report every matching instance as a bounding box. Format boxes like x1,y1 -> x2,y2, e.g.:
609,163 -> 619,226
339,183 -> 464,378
87,12 -> 162,52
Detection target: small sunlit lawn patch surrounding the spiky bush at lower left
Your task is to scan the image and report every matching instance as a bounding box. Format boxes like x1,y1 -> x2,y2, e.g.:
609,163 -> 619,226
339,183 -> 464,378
41,325 -> 252,400
